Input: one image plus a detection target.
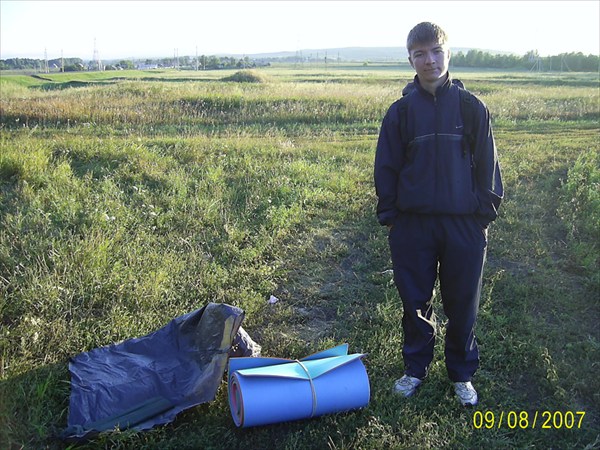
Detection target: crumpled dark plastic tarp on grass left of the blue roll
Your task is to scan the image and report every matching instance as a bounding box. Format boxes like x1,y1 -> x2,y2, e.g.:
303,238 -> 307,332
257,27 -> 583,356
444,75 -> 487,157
62,303 -> 260,440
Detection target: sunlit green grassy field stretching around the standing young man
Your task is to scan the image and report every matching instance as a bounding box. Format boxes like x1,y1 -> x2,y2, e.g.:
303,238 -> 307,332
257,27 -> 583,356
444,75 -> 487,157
0,65 -> 600,449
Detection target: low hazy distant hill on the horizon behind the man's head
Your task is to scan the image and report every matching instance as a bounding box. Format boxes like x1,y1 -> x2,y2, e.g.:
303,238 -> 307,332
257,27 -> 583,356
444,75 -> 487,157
219,47 -> 510,62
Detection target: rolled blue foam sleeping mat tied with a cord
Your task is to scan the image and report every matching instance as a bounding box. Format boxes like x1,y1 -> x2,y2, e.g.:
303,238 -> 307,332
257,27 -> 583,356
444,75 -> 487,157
228,344 -> 370,427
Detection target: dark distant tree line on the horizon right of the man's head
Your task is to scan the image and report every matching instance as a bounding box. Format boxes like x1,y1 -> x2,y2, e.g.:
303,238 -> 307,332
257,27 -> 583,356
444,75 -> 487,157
450,50 -> 600,72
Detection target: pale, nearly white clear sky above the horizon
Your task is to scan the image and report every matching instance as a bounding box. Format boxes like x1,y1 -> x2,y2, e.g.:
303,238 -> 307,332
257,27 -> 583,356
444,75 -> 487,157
0,0 -> 600,60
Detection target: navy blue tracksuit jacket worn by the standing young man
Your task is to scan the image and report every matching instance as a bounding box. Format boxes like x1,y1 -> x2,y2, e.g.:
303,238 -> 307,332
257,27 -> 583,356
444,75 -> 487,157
375,76 -> 503,229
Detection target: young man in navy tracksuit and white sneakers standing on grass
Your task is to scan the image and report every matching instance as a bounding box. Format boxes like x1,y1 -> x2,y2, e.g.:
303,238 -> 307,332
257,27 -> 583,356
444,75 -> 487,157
375,22 -> 503,405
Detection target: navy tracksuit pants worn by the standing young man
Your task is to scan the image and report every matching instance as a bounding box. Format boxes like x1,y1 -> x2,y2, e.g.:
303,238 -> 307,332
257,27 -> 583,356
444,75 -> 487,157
389,213 -> 487,382
